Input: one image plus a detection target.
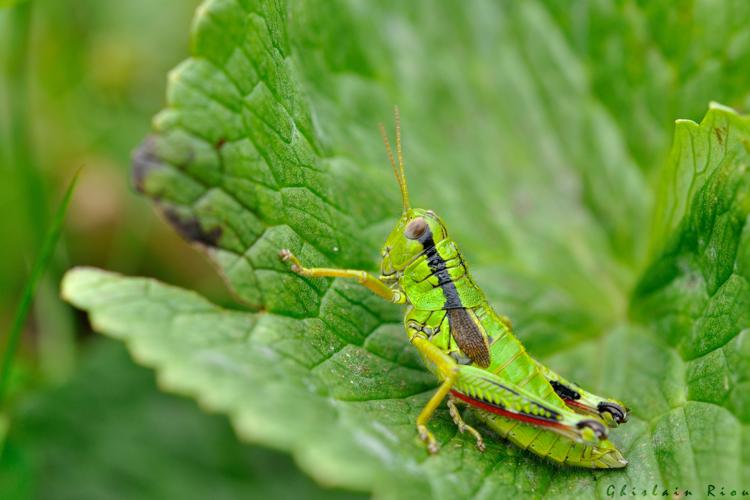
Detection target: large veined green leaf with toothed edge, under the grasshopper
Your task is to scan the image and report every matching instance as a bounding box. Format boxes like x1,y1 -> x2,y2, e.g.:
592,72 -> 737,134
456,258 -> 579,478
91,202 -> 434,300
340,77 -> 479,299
63,0 -> 750,498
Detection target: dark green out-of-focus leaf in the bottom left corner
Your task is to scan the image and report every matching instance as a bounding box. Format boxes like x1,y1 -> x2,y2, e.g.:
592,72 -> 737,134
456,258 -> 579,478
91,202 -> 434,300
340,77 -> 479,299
0,340 -> 364,500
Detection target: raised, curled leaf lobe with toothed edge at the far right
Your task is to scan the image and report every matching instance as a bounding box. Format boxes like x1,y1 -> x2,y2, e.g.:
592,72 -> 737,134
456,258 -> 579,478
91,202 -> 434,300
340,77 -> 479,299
632,105 -> 750,394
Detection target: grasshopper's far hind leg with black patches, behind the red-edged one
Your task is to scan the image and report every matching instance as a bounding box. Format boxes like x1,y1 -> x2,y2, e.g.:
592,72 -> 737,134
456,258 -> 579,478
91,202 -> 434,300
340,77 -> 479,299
534,360 -> 629,427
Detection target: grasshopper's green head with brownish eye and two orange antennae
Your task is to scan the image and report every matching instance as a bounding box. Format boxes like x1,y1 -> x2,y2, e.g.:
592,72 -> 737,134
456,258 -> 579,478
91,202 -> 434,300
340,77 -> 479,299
380,108 -> 448,279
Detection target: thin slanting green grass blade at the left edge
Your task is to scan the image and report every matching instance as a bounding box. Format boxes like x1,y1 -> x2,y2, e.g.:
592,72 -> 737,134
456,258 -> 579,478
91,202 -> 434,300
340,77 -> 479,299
0,170 -> 80,407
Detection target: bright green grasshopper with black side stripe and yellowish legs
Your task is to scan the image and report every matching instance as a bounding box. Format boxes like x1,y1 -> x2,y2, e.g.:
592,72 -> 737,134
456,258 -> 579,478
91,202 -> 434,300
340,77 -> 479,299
279,108 -> 628,468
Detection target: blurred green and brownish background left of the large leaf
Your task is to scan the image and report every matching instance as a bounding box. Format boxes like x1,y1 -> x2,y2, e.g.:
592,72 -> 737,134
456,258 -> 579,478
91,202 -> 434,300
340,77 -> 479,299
0,0 -> 362,499
